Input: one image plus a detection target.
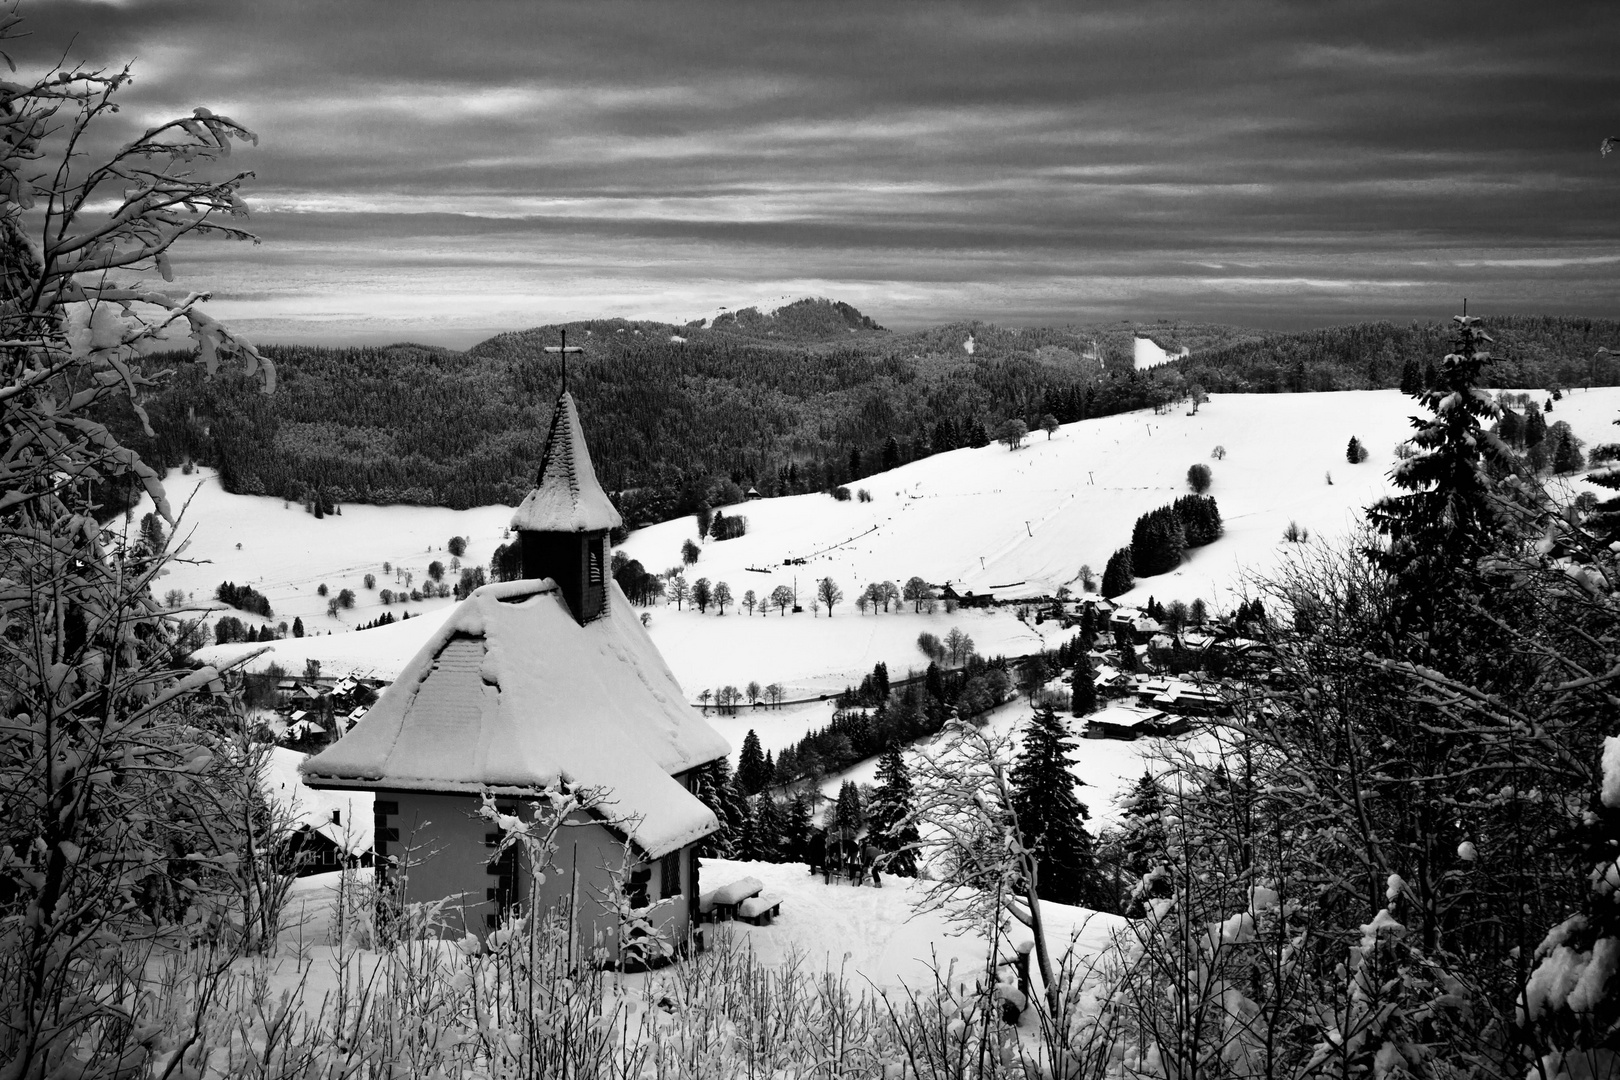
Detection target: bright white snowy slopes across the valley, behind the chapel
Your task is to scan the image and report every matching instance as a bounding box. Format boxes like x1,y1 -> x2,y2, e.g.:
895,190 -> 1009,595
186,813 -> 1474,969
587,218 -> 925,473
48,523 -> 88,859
177,387 -> 1620,701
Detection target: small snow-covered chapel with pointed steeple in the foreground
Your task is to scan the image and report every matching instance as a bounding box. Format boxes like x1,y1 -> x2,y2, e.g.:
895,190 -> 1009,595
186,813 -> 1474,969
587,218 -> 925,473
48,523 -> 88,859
303,389 -> 729,962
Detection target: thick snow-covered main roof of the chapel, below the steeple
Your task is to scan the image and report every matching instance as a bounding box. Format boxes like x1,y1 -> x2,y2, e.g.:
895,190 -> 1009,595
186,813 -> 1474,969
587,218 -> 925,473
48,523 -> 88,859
303,580 -> 729,858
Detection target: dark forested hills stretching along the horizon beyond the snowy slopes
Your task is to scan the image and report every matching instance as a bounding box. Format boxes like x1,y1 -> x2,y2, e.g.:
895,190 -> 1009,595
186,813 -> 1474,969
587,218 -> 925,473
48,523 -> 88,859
109,301 -> 1620,525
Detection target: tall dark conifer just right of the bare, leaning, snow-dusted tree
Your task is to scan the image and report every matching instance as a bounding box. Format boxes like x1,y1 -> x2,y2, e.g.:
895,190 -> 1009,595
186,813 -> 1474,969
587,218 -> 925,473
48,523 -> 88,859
1009,706 -> 1098,904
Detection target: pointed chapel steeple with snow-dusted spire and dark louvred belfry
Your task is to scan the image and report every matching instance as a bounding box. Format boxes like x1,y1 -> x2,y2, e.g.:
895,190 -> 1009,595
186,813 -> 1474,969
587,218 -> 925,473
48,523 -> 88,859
512,369 -> 624,627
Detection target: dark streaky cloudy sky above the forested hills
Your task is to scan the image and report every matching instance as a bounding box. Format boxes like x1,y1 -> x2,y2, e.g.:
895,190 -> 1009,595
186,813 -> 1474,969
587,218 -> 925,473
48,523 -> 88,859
11,0 -> 1620,345
